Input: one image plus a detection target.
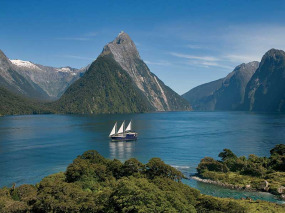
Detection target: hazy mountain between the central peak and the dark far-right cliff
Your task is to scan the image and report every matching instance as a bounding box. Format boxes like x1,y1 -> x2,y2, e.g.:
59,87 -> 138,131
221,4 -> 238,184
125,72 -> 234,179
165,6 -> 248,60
183,61 -> 259,110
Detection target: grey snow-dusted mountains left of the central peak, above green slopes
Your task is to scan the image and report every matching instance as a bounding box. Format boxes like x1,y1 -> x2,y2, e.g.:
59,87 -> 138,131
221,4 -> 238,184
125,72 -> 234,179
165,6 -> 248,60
0,50 -> 86,101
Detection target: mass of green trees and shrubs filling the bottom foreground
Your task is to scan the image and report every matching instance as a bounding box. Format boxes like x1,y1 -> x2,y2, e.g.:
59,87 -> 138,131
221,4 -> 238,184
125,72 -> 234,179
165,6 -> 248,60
0,150 -> 285,213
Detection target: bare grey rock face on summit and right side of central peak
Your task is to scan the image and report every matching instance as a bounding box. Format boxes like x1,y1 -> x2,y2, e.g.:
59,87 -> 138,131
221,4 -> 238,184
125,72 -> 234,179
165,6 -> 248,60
101,32 -> 190,111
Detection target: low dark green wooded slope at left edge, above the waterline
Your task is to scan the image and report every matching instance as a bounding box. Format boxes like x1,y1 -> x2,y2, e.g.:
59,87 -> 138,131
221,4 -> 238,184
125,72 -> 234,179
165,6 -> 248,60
0,87 -> 51,116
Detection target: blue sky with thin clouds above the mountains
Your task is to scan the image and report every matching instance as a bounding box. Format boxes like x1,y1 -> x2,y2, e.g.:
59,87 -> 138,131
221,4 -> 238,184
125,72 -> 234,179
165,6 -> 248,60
0,0 -> 285,94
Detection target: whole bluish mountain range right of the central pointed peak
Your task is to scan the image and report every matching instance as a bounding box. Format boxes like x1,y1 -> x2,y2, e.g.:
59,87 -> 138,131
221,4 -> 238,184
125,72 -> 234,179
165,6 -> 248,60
183,49 -> 285,112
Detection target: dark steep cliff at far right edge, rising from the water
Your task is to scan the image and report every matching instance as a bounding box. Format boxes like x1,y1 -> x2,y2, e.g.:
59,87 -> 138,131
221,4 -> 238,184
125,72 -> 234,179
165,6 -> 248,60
243,49 -> 285,112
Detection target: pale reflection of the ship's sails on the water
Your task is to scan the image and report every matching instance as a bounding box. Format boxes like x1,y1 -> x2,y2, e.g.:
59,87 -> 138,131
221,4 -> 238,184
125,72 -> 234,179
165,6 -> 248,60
109,141 -> 136,161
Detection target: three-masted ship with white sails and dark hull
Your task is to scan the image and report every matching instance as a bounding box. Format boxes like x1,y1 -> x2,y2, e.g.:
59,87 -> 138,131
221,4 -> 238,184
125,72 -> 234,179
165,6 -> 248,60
109,121 -> 138,141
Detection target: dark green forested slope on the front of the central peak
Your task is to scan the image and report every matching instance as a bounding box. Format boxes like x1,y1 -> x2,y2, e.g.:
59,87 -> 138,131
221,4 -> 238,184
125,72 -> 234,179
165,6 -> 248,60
52,55 -> 152,114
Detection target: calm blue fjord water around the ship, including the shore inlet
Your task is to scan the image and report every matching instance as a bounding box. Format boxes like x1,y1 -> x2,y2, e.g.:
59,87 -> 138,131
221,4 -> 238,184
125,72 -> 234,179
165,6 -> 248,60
0,112 -> 285,202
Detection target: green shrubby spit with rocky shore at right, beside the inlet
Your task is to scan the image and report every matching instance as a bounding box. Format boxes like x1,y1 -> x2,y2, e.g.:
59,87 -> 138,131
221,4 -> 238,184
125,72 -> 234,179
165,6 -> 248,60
197,144 -> 285,199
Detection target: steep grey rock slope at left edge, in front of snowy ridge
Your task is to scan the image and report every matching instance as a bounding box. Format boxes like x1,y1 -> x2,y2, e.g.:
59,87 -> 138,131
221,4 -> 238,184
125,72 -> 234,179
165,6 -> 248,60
0,50 -> 49,100
